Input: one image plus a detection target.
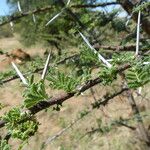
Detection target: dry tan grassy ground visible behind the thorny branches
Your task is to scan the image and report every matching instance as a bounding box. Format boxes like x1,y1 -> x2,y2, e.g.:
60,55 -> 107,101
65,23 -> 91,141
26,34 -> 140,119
0,37 -> 149,150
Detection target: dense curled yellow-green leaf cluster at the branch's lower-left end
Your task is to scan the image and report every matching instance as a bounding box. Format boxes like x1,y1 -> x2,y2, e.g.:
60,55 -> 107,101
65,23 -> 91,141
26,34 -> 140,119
3,108 -> 39,141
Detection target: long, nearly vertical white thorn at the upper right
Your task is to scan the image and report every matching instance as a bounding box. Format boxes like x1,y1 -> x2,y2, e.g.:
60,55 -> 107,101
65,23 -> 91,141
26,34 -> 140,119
135,11 -> 141,56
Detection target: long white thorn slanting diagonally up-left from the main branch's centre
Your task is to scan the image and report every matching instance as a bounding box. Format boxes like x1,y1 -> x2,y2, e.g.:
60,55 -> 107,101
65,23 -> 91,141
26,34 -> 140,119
79,32 -> 112,68
